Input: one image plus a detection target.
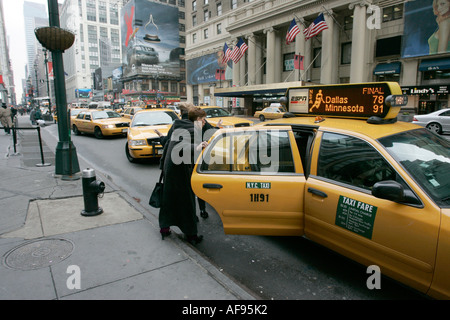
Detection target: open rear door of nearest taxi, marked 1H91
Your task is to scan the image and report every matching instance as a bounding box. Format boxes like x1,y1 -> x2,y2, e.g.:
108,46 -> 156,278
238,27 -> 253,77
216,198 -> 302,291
191,126 -> 306,236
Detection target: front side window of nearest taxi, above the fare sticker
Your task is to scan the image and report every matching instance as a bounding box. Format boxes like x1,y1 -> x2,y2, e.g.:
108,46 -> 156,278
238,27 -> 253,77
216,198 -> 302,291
317,132 -> 398,190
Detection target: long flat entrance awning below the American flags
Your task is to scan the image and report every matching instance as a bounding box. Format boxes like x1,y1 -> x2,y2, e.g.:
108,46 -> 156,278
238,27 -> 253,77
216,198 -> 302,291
214,81 -> 304,98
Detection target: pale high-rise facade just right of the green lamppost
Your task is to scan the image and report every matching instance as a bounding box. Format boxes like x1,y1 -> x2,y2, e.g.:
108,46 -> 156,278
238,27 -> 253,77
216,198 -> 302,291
59,0 -> 126,103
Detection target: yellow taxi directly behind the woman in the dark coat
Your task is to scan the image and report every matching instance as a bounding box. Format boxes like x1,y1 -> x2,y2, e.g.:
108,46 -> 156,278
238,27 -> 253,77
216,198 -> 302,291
125,108 -> 179,162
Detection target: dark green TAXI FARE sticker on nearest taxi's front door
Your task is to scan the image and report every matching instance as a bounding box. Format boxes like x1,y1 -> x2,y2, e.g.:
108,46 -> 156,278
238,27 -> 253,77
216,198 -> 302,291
335,196 -> 377,239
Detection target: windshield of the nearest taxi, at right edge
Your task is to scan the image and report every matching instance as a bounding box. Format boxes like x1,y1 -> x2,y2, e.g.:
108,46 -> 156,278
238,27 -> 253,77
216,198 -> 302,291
379,128 -> 450,207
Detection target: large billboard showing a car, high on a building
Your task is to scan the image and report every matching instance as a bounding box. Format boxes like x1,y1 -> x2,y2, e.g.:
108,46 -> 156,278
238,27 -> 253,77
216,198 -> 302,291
121,0 -> 182,79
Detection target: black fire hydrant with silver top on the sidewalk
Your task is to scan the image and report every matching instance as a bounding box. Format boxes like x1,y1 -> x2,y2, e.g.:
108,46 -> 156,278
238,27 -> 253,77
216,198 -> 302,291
81,168 -> 105,216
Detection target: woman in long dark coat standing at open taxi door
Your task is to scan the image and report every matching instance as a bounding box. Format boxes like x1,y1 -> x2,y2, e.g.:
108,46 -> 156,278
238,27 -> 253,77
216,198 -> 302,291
155,107 -> 208,244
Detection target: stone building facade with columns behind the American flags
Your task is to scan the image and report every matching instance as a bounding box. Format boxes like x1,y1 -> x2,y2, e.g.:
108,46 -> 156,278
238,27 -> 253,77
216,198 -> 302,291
186,0 -> 450,114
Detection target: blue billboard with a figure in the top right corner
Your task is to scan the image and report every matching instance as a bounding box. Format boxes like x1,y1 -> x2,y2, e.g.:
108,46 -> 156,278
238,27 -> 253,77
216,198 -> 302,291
402,0 -> 450,58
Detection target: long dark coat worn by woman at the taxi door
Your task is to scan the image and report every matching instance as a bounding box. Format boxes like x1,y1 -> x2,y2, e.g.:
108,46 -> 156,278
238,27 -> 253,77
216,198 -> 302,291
159,120 -> 197,235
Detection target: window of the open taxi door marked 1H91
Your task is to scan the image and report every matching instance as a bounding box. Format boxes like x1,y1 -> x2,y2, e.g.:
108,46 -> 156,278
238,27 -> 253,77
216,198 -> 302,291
200,130 -> 295,173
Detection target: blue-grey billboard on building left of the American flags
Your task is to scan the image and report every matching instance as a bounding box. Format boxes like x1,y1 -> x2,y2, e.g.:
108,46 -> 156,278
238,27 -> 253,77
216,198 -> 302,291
186,51 -> 233,85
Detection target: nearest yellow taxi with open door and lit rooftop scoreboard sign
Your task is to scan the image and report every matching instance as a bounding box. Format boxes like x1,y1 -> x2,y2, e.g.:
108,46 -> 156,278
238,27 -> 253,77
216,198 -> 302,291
192,82 -> 450,299
